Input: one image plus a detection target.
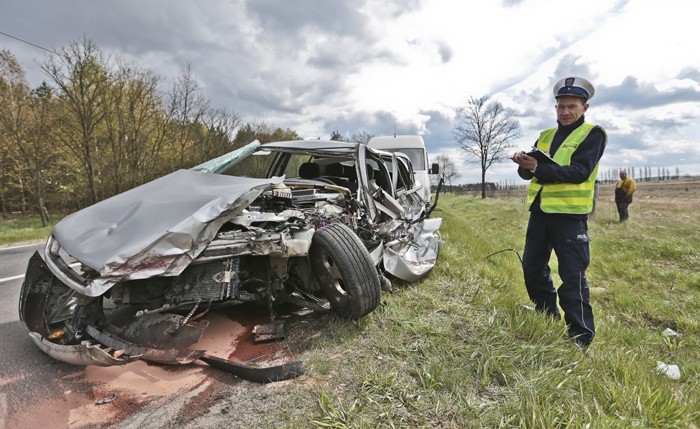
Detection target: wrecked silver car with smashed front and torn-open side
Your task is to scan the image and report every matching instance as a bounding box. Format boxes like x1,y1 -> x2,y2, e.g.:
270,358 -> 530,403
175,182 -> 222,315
19,140 -> 441,381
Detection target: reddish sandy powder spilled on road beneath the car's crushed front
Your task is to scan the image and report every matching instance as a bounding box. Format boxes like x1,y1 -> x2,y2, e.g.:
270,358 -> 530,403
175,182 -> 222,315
6,304 -> 334,429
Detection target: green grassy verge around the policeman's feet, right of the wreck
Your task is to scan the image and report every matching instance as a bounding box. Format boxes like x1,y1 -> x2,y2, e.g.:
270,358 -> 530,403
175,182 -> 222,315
256,192 -> 700,428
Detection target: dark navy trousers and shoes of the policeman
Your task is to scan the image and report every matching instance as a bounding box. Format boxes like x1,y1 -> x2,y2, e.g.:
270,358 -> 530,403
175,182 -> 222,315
523,211 -> 595,346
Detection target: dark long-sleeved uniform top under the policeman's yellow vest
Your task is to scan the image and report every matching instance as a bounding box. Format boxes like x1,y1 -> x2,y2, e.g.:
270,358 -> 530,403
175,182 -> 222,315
518,115 -> 606,218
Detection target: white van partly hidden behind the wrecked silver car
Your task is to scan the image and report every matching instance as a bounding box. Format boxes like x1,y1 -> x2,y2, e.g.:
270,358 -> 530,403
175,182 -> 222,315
367,135 -> 438,201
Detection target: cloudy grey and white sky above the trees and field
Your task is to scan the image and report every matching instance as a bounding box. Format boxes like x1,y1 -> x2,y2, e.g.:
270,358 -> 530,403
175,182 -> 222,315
0,0 -> 700,182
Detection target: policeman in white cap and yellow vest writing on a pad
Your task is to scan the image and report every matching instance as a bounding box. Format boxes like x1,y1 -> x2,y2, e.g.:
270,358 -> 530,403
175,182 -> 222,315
512,77 -> 607,348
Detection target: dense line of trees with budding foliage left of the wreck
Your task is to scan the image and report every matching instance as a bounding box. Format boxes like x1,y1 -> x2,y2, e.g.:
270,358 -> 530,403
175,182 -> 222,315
0,38 -> 300,225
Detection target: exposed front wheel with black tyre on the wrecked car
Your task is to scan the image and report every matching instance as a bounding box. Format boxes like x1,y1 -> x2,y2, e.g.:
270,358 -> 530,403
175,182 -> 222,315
309,223 -> 381,319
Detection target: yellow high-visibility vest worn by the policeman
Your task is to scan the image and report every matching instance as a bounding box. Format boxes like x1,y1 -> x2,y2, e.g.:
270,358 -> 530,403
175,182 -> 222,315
527,122 -> 598,214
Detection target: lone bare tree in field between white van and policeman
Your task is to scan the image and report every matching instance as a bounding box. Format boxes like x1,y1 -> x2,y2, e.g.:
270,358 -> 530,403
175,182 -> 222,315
452,96 -> 520,198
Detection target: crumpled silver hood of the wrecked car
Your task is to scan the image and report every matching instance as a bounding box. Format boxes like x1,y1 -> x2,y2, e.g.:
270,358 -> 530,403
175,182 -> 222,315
52,170 -> 283,281
